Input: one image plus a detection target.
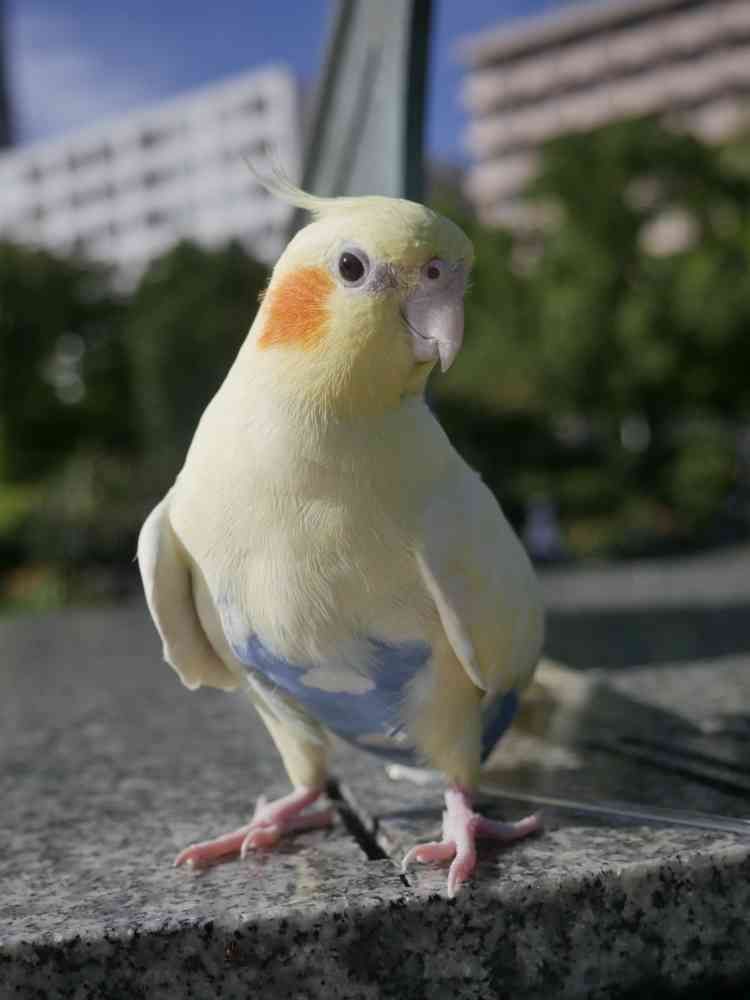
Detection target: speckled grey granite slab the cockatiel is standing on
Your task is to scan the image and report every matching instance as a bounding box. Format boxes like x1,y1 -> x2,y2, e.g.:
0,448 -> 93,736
0,605 -> 750,1000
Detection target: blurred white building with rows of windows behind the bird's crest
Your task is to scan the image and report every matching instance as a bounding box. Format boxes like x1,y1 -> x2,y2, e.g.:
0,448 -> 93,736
0,67 -> 301,281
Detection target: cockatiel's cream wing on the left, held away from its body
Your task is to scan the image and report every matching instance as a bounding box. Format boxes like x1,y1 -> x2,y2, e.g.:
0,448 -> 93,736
138,493 -> 242,690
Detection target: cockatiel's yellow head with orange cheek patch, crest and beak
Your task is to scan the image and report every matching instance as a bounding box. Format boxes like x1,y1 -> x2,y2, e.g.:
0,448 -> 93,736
248,178 -> 473,413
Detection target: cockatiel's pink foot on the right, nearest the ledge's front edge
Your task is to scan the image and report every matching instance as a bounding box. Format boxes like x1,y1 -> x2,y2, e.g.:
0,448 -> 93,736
401,787 -> 542,899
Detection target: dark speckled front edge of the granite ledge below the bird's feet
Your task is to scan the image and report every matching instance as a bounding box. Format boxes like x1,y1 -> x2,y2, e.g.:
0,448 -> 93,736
0,846 -> 750,1000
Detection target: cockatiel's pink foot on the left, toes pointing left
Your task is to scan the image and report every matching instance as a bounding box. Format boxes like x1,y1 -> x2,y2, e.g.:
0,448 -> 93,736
174,788 -> 335,868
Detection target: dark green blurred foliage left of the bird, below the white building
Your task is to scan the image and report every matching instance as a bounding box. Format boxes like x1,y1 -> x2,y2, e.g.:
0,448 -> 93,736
0,243 -> 267,597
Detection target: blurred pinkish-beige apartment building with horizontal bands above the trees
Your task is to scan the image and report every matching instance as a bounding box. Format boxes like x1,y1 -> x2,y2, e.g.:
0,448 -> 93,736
461,0 -> 750,226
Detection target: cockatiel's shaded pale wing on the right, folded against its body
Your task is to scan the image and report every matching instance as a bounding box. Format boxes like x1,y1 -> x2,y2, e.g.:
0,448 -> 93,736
417,466 -> 544,694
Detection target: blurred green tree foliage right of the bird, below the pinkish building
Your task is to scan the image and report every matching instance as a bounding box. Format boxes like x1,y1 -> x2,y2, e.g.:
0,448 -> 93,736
436,119 -> 750,551
